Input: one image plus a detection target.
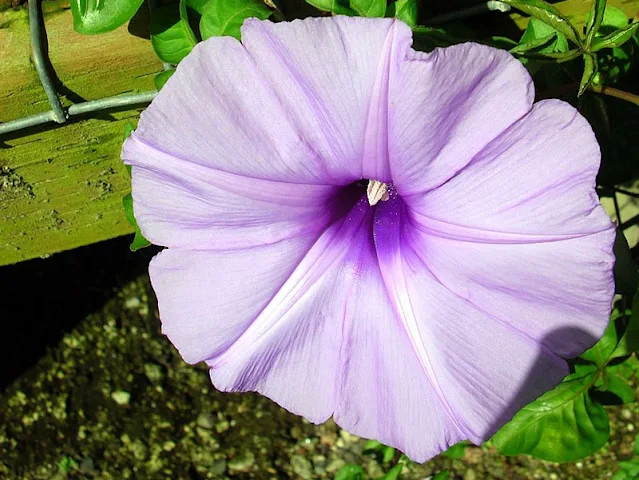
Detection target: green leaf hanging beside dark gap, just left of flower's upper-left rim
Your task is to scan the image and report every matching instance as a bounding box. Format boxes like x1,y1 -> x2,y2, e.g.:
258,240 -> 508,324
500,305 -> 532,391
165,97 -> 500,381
150,0 -> 197,65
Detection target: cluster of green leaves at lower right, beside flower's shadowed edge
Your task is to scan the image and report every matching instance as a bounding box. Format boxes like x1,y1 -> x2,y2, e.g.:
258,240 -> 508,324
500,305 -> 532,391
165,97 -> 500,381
492,295 -> 639,462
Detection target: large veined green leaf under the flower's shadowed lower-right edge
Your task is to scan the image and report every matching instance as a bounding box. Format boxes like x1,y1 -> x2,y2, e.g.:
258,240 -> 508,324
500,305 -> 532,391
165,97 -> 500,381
493,374 -> 610,462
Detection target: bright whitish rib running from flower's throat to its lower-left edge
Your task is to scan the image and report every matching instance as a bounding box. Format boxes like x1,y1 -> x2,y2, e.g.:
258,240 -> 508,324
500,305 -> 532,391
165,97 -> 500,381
207,197 -> 372,374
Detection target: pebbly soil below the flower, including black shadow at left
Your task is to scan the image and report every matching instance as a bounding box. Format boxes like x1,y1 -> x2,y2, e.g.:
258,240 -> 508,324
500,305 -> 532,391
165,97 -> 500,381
0,239 -> 639,480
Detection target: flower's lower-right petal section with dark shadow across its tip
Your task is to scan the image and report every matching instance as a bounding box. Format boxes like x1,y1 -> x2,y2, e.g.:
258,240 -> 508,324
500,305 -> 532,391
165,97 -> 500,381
375,198 -> 570,444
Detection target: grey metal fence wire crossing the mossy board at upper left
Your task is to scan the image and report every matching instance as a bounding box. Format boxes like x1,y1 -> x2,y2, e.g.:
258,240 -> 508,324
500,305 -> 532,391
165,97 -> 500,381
0,0 -> 158,139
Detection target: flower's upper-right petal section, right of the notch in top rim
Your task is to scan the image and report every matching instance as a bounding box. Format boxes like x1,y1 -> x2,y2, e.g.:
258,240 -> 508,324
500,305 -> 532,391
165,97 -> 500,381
388,43 -> 535,197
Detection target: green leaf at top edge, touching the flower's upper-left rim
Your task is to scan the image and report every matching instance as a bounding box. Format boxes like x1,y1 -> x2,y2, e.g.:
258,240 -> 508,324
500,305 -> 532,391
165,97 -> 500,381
200,0 -> 273,40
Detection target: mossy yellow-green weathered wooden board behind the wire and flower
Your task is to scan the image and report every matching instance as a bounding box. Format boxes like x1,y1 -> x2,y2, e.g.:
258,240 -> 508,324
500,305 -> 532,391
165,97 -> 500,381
0,0 -> 639,265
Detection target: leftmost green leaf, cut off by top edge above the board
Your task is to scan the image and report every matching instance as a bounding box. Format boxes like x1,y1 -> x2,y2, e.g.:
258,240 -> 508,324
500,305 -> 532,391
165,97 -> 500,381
71,0 -> 143,35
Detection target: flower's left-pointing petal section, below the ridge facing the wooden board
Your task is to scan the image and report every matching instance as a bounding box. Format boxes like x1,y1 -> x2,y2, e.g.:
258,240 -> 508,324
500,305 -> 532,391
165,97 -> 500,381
122,133 -> 336,250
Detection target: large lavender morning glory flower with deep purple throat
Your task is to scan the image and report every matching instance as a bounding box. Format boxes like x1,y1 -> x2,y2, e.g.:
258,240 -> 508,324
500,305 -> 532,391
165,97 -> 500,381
123,17 -> 614,461
